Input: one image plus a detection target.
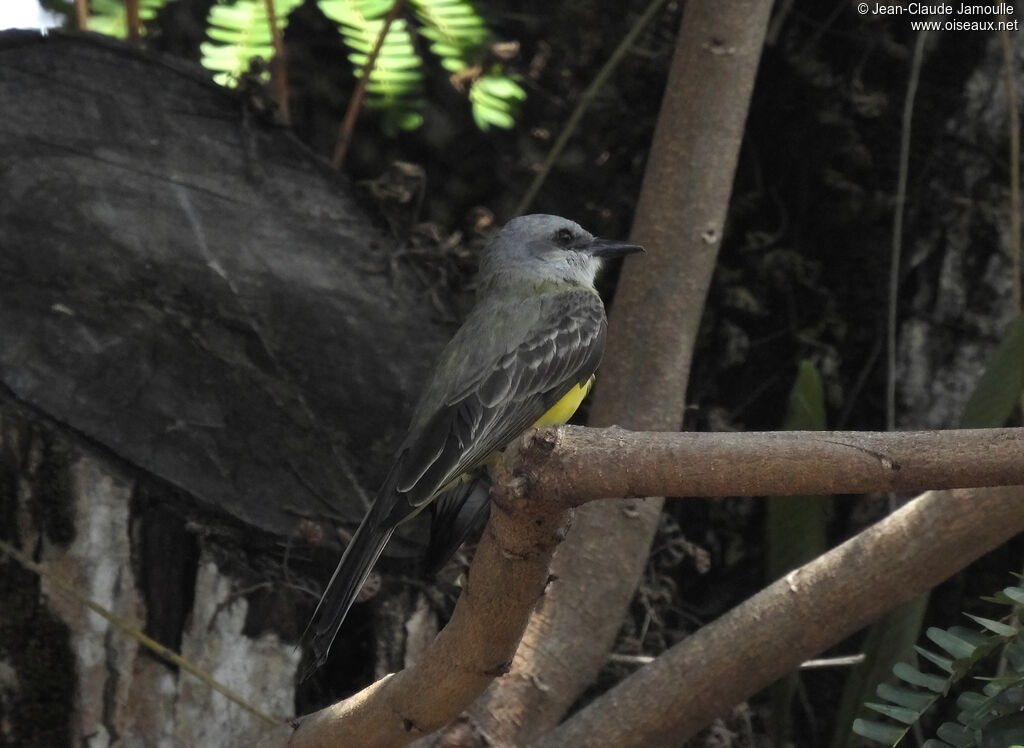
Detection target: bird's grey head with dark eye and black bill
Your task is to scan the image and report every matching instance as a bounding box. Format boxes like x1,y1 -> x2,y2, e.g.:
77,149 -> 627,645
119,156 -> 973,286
480,214 -> 643,287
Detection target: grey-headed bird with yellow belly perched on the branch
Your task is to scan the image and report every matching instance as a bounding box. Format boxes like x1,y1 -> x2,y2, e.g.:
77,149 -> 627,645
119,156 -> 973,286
301,214 -> 643,679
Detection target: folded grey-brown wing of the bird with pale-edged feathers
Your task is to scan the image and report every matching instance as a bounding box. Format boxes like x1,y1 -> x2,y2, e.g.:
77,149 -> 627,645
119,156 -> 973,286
388,289 -> 606,514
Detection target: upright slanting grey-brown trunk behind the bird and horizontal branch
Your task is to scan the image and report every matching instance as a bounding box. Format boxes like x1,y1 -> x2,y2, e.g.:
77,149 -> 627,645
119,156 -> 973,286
448,0 -> 772,744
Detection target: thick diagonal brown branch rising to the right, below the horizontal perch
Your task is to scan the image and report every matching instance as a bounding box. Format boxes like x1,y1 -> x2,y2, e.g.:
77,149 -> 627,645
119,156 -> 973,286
534,481 -> 1024,748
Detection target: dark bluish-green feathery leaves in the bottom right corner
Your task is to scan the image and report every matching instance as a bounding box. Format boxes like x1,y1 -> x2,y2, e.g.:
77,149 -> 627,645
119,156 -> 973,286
853,585 -> 1024,748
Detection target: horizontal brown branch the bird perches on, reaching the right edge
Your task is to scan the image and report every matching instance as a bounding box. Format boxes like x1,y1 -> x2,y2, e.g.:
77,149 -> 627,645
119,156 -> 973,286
524,426 -> 1024,505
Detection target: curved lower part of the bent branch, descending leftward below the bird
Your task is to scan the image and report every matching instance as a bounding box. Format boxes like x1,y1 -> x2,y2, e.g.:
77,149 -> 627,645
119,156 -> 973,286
263,448 -> 568,748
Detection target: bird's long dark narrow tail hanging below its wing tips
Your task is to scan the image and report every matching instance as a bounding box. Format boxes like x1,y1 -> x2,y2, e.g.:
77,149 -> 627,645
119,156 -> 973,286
300,506 -> 394,680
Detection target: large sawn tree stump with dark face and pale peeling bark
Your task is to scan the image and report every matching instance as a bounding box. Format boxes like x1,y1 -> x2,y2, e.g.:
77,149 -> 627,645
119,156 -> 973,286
0,32 -> 453,745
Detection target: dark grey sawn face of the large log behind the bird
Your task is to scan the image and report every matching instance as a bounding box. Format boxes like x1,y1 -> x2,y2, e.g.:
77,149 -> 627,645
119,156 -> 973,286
0,32 -> 451,536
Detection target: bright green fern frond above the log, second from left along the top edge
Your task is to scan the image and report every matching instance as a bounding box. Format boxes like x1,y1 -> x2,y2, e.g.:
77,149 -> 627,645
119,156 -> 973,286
200,0 -> 302,85
